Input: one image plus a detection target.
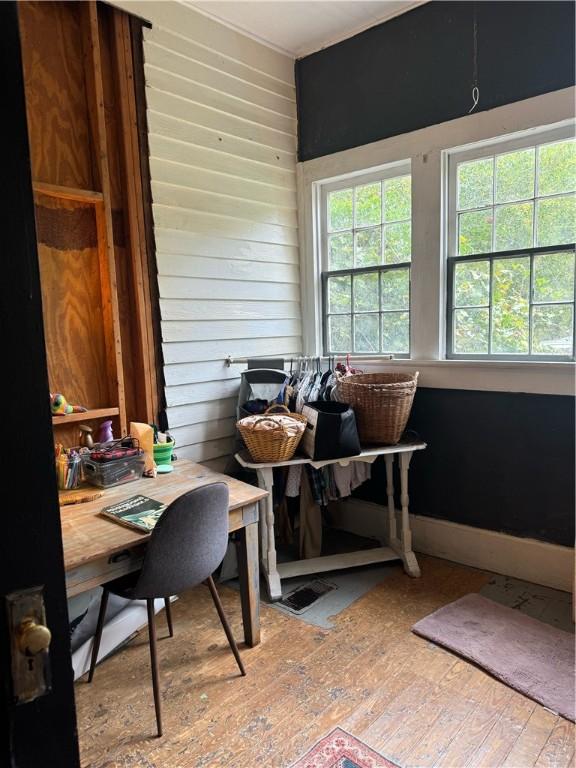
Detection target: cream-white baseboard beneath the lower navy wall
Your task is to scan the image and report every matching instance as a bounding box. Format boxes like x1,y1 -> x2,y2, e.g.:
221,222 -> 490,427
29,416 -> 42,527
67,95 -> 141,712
332,499 -> 574,592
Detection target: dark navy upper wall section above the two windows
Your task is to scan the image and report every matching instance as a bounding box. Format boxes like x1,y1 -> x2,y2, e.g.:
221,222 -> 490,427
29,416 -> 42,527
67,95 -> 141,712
296,1 -> 575,160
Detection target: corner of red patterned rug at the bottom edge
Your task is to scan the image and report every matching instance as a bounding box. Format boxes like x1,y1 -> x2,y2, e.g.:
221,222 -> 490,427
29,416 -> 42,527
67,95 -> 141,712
291,728 -> 398,768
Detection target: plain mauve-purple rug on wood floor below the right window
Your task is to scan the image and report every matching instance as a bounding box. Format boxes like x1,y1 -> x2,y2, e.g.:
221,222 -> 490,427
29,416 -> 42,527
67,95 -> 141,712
412,594 -> 575,721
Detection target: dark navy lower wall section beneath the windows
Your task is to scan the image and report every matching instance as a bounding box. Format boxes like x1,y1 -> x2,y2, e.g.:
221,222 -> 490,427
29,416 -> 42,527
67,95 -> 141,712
356,388 -> 575,547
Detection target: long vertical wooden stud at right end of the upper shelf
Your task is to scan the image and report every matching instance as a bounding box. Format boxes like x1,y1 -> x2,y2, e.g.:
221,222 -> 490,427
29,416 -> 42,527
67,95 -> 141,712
81,0 -> 128,434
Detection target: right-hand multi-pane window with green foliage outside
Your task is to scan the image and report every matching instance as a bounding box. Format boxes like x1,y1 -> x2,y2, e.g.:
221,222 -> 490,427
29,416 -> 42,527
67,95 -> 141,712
447,129 -> 576,360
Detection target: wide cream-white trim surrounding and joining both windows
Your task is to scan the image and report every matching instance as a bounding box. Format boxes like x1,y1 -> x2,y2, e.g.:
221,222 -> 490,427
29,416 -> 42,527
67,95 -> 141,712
297,88 -> 576,395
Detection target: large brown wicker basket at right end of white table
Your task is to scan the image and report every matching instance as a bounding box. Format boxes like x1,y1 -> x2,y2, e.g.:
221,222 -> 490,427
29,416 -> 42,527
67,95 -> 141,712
338,371 -> 418,445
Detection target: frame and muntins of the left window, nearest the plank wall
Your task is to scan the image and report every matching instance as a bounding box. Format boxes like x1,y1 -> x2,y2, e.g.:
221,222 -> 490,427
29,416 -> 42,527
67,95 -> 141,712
316,160 -> 414,360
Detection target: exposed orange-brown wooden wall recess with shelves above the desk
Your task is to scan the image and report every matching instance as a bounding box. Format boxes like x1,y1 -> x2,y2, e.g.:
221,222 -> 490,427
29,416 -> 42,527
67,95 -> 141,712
18,0 -> 159,447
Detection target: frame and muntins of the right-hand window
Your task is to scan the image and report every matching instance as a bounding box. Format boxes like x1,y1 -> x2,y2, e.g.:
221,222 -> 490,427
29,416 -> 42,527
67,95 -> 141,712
444,125 -> 576,363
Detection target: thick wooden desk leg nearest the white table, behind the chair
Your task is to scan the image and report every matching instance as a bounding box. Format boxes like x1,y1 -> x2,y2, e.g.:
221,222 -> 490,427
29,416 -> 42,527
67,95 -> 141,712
238,523 -> 260,647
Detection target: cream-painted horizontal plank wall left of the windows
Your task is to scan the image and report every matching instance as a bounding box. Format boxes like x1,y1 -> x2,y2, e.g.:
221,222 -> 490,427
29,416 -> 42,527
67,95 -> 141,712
114,0 -> 302,463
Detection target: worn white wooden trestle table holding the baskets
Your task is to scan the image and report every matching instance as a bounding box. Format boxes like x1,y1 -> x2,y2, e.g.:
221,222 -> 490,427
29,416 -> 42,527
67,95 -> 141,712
235,442 -> 426,600
